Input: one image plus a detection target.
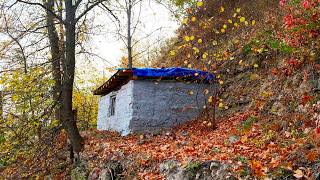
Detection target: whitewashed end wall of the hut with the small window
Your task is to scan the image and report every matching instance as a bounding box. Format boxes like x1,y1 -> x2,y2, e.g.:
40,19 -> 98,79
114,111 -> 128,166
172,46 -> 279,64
97,81 -> 133,135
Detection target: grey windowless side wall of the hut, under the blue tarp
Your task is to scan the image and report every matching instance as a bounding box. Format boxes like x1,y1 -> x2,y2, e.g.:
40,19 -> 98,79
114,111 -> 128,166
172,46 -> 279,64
130,80 -> 213,131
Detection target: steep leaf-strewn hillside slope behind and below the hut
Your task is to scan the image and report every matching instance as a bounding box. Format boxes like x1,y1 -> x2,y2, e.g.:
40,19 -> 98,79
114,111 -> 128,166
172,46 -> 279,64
4,0 -> 320,179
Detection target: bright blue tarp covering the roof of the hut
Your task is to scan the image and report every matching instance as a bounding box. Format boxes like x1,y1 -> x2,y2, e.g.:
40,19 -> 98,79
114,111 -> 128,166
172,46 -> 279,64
120,68 -> 215,82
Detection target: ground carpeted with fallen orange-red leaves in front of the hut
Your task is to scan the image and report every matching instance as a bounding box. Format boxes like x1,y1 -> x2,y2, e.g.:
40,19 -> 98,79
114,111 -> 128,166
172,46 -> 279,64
77,111 -> 320,179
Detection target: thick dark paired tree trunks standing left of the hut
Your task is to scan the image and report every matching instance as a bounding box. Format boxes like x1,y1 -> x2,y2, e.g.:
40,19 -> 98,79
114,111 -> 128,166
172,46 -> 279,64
46,0 -> 82,153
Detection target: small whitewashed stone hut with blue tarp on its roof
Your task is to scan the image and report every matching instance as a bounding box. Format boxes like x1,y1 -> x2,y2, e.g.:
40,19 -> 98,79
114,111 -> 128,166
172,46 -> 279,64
94,68 -> 215,135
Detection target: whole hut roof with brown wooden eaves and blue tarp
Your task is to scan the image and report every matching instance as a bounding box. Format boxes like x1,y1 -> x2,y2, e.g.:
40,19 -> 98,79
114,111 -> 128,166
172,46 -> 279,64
93,68 -> 215,95
